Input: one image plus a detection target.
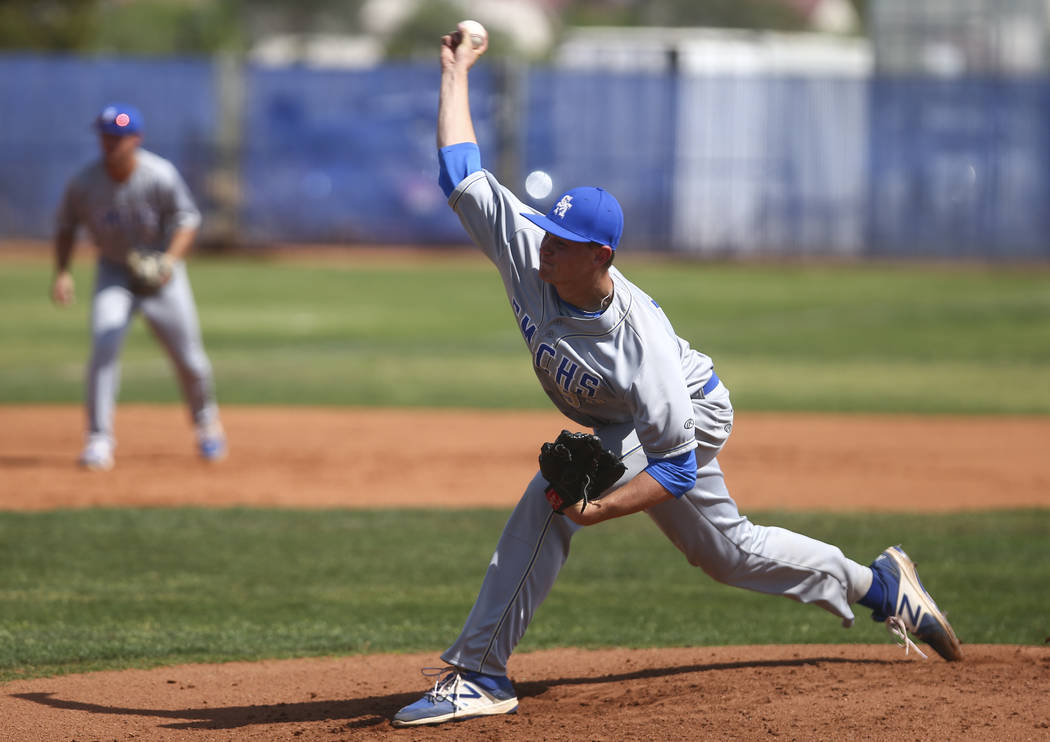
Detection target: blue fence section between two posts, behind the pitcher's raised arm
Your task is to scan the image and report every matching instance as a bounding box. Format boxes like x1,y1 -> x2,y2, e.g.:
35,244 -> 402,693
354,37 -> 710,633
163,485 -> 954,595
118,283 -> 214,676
240,65 -> 494,243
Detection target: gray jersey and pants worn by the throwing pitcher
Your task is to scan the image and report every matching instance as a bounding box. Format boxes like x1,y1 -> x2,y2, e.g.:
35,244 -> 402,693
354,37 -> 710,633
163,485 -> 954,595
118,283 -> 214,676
442,170 -> 872,675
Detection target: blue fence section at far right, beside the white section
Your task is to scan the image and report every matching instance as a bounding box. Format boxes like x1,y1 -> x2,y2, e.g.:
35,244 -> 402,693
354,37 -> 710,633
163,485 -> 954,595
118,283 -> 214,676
868,78 -> 1050,258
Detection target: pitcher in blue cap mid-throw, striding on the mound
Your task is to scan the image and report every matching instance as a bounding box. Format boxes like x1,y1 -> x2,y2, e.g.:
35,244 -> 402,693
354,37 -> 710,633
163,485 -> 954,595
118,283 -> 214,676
393,21 -> 962,726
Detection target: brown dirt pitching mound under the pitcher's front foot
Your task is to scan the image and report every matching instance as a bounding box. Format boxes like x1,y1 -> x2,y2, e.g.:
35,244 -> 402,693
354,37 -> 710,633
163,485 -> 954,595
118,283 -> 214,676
0,644 -> 1050,742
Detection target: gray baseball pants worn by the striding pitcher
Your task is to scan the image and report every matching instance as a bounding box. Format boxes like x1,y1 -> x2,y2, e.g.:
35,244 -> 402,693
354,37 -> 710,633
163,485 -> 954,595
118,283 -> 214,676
441,386 -> 872,675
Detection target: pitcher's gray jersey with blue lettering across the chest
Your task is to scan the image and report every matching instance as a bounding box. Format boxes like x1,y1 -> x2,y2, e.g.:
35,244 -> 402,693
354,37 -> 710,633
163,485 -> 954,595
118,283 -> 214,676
448,170 -> 712,459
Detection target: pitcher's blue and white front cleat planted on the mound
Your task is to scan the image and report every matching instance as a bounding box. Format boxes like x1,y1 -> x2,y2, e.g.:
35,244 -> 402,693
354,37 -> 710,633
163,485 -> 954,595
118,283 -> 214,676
391,667 -> 518,726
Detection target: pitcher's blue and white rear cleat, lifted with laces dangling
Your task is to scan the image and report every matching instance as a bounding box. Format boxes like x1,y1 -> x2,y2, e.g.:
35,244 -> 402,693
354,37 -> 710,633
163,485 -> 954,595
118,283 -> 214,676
872,546 -> 963,662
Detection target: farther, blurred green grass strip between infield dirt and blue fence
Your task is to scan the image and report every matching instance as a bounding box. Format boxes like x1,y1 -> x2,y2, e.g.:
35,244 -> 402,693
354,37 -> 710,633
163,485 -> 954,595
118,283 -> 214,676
0,256 -> 1050,415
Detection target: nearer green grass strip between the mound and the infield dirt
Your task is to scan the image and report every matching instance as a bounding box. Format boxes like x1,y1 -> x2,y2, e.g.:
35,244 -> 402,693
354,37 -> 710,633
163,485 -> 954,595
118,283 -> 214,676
0,509 -> 1050,680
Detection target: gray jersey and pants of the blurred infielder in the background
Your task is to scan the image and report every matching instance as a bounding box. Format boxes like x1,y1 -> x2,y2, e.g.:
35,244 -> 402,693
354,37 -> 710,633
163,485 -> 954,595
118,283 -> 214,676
58,149 -> 217,442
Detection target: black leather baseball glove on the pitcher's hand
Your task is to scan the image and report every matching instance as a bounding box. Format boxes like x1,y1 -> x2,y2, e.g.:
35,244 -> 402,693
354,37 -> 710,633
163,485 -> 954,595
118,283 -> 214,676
540,430 -> 627,513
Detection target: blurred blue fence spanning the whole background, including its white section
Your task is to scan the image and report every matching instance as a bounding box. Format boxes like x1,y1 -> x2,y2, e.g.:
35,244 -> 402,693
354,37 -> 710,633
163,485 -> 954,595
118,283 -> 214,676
0,55 -> 1050,258
